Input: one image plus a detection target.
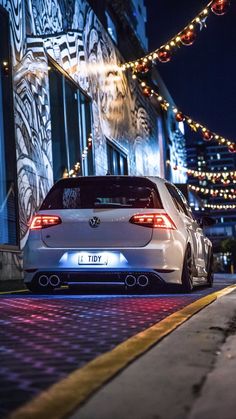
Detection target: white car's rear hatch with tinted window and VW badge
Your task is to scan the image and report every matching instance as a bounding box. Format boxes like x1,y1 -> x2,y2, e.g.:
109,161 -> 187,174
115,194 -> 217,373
40,176 -> 163,248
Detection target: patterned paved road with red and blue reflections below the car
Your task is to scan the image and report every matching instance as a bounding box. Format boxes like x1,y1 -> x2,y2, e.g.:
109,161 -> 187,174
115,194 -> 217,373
0,277 -> 235,418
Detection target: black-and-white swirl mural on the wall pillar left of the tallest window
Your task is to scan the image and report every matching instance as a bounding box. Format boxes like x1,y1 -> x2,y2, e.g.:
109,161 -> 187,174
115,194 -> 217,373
14,39 -> 52,247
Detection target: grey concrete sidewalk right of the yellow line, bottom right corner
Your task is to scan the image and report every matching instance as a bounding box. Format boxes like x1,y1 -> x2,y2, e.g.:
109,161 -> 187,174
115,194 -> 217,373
71,286 -> 236,419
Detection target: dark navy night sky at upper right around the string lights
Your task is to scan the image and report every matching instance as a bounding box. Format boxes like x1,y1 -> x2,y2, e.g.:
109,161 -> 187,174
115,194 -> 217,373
145,0 -> 236,142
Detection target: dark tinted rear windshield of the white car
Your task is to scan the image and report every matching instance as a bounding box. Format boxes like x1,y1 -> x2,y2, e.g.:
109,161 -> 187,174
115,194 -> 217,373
40,177 -> 162,210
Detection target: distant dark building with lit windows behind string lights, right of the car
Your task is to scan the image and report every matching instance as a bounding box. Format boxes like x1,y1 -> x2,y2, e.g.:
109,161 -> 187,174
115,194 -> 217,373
187,141 -> 236,272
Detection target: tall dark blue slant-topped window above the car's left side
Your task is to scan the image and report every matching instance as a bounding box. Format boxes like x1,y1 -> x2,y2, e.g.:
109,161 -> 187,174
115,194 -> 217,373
49,63 -> 93,181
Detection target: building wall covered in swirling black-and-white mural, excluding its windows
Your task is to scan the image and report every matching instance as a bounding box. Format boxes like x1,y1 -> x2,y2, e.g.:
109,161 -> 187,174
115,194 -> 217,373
0,0 -> 184,279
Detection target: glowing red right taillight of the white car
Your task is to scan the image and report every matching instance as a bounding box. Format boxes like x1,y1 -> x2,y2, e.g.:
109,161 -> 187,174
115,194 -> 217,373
129,214 -> 176,230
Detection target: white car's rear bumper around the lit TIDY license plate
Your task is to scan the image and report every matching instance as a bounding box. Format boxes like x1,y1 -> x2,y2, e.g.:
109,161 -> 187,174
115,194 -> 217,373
24,242 -> 184,284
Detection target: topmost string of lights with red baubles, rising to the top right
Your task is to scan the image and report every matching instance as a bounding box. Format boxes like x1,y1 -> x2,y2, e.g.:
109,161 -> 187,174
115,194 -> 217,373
121,0 -> 229,72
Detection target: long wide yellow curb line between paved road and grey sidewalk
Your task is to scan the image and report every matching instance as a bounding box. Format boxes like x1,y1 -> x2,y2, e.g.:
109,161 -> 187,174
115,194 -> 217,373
9,285 -> 236,419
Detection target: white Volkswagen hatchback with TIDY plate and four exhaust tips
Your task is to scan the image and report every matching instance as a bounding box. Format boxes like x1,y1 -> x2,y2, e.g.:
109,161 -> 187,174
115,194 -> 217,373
24,176 -> 213,292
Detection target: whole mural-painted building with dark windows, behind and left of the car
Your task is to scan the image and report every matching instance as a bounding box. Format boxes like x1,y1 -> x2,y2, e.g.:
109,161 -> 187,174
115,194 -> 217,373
0,0 -> 186,280
